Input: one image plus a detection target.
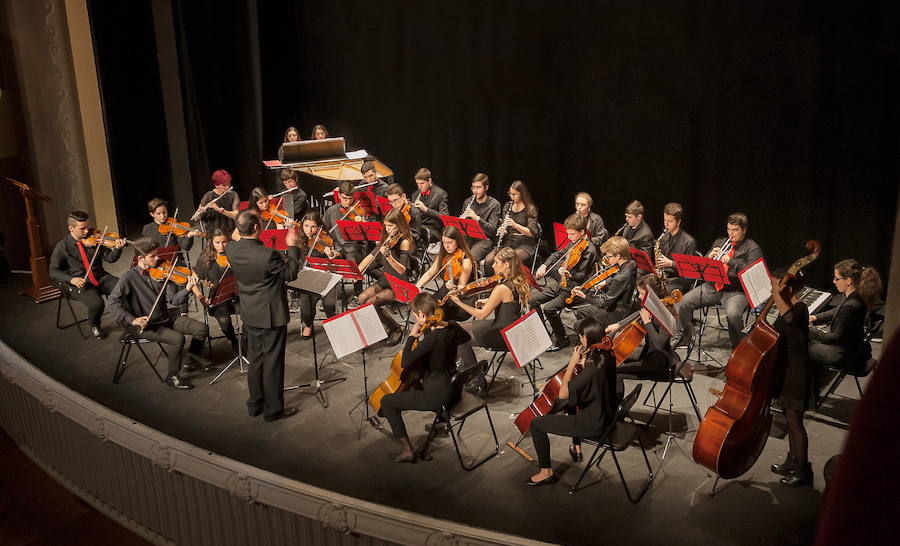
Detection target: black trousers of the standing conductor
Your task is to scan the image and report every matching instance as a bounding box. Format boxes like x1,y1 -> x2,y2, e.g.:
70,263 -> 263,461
244,324 -> 287,416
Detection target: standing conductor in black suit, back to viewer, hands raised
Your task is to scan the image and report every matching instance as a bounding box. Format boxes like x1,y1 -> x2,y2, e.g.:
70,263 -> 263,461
225,209 -> 300,421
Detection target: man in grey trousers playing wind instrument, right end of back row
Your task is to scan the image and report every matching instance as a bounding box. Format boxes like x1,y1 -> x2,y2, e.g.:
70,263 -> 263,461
676,212 -> 763,349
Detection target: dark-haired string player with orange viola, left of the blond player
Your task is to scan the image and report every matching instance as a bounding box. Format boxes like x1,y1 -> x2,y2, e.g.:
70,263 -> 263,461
529,213 -> 597,351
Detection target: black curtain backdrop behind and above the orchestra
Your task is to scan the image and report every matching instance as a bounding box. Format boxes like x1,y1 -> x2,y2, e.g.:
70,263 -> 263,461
90,0 -> 900,286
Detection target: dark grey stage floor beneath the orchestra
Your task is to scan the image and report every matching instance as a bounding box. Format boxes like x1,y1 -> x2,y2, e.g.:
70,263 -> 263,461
0,260 -> 880,545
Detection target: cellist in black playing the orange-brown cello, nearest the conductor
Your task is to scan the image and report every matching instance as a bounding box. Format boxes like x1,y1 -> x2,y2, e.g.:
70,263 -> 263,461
381,292 -> 469,463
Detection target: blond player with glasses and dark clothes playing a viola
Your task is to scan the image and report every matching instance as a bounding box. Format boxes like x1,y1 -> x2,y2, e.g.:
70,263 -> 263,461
572,235 -> 637,324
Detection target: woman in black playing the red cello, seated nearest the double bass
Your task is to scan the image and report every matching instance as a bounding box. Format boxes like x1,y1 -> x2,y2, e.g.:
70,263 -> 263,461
525,317 -> 617,486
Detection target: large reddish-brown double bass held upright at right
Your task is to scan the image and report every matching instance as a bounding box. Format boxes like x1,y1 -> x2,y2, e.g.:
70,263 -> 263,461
693,241 -> 820,479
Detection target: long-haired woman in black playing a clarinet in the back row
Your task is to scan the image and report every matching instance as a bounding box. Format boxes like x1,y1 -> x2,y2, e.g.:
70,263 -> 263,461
484,180 -> 540,271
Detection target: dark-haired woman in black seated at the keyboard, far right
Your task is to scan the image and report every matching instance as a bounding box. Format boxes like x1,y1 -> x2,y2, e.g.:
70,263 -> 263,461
809,259 -> 882,368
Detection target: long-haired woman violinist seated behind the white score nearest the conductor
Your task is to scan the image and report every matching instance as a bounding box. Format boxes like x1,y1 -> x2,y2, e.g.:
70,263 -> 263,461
358,209 -> 416,345
